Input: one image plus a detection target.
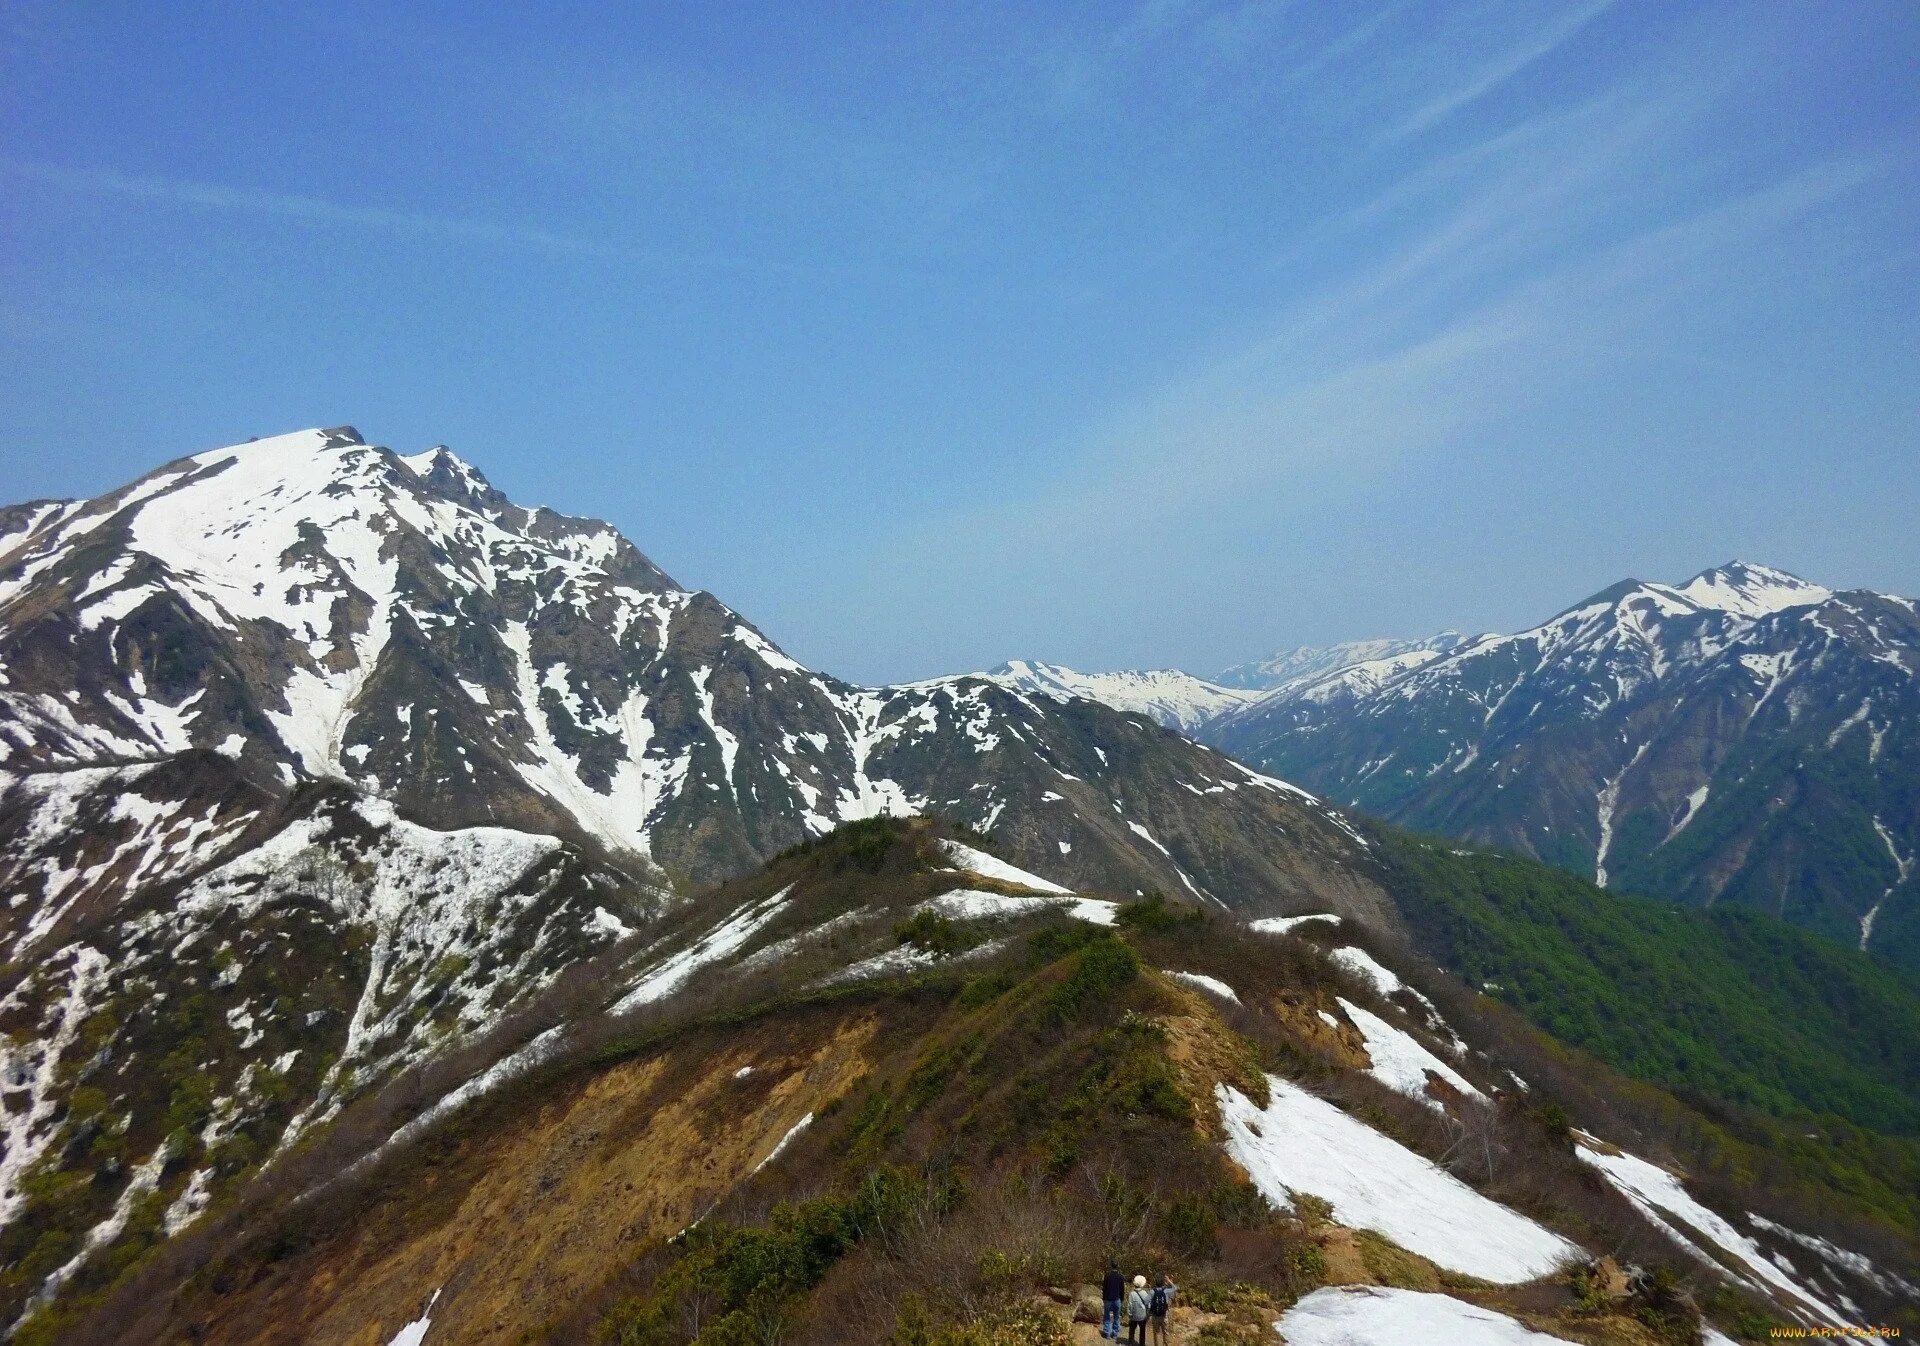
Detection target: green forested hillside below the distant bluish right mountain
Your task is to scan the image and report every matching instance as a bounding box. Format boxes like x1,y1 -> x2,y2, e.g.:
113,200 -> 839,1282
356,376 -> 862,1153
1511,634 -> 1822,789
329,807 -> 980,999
1379,829 -> 1920,1137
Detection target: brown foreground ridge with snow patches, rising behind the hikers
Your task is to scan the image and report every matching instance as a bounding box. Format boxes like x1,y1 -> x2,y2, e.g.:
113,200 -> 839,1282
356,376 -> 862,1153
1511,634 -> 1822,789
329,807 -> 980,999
27,820 -> 1916,1346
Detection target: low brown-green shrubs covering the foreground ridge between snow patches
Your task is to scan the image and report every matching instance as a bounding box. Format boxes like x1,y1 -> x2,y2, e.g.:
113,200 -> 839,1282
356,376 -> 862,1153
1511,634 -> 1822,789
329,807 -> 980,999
48,820 -> 1905,1346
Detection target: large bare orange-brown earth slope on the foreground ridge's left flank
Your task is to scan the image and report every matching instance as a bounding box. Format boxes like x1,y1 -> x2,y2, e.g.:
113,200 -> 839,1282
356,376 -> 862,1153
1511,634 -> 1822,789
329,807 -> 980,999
196,1012 -> 879,1346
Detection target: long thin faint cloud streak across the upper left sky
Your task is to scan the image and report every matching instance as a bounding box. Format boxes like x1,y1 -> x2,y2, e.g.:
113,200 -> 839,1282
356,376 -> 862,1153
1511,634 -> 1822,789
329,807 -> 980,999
0,159 -> 818,275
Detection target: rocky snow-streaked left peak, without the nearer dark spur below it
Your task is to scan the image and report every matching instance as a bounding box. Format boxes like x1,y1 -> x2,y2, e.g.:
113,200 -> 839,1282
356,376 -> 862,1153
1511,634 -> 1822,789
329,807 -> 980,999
0,430 -> 1390,891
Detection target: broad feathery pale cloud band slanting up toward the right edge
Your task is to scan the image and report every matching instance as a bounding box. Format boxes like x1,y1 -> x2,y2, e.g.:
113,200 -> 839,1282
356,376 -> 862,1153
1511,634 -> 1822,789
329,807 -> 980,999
871,119 -> 1914,652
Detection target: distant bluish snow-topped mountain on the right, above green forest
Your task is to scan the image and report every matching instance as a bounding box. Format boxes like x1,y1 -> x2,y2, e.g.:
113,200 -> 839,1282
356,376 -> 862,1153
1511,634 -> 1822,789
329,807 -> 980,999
1202,563 -> 1920,966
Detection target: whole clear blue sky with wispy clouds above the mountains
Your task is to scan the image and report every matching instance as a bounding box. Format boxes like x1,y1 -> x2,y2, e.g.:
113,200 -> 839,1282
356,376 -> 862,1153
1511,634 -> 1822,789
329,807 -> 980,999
0,0 -> 1920,680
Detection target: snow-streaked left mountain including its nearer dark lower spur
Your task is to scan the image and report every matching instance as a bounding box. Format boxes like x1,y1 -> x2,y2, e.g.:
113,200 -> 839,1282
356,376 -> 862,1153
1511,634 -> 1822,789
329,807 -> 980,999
0,428 -> 1392,1285
